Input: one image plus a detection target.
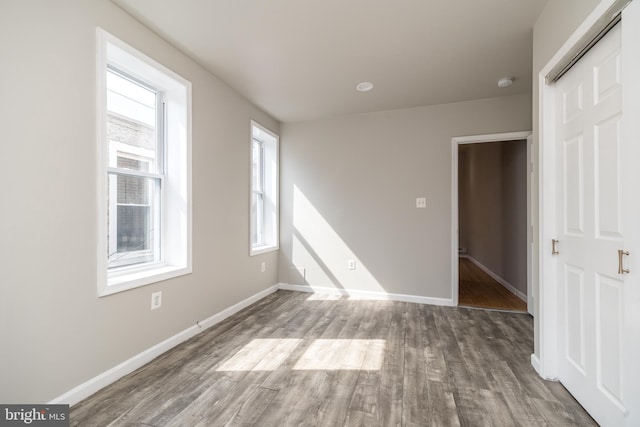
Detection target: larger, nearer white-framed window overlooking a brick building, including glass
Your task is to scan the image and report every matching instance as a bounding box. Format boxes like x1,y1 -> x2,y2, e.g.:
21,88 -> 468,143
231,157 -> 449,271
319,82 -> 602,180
98,30 -> 191,295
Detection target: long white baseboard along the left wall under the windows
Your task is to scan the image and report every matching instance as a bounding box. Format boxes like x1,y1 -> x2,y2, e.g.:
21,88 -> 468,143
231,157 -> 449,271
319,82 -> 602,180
49,285 -> 278,405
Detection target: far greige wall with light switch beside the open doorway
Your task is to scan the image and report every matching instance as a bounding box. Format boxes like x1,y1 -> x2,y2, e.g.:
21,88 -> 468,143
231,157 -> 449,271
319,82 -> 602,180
279,95 -> 531,299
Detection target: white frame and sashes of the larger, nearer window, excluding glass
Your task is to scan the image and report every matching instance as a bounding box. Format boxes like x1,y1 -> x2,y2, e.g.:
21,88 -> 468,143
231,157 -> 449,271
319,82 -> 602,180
96,28 -> 192,297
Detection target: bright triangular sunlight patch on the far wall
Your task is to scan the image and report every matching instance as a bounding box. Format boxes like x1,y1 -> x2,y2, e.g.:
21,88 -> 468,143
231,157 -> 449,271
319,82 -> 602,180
291,185 -> 385,294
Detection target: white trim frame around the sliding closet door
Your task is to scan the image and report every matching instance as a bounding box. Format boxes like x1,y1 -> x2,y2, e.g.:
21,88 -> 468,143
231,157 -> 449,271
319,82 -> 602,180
532,0 -> 615,379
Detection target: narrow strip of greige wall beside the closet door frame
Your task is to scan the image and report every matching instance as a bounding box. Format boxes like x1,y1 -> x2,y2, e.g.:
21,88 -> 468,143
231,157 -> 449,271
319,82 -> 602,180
532,0 -> 601,362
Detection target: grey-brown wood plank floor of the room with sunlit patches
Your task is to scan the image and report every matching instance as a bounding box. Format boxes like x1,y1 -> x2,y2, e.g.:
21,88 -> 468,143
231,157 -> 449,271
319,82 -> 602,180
70,291 -> 596,427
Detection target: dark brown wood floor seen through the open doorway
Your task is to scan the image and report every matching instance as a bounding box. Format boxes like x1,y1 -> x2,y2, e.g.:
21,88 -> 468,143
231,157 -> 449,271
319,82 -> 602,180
458,257 -> 527,313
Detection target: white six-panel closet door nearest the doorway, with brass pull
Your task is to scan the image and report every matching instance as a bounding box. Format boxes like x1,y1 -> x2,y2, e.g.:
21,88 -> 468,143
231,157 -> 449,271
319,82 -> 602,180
556,25 -> 626,426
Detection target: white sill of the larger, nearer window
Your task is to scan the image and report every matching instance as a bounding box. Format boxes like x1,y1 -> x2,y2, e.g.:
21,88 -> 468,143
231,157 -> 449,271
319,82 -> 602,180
98,264 -> 192,297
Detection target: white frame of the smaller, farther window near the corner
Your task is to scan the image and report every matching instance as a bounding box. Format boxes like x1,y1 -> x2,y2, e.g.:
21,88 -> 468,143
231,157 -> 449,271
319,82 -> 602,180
249,120 -> 280,256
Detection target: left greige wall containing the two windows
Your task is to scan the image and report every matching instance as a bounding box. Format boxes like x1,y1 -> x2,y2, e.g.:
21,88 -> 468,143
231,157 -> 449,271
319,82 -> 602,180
0,0 -> 278,403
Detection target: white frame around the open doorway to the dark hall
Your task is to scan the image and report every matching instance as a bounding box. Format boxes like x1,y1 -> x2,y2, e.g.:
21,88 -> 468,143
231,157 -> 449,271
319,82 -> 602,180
451,131 -> 533,314
